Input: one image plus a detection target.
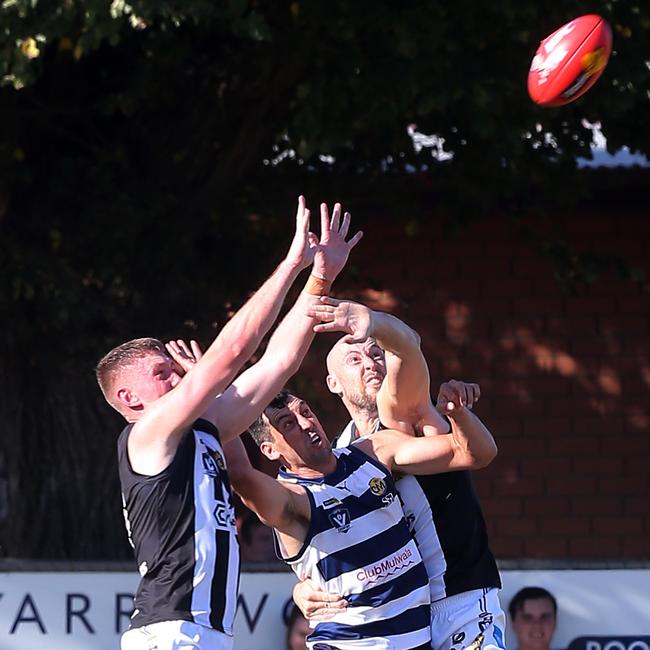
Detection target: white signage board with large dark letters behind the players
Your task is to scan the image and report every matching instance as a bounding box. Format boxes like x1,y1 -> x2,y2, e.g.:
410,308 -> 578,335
0,569 -> 650,650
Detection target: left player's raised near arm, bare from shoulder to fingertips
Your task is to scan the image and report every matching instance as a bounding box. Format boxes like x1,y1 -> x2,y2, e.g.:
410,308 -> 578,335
128,197 -> 316,466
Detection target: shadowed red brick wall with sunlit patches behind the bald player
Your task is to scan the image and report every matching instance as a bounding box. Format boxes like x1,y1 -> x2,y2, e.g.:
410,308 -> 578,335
299,206 -> 650,560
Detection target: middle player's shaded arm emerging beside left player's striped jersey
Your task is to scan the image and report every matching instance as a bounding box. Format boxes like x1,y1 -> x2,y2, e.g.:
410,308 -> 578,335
224,438 -> 311,544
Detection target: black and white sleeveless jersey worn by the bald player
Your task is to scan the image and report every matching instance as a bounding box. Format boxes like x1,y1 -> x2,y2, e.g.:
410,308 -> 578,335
335,422 -> 501,602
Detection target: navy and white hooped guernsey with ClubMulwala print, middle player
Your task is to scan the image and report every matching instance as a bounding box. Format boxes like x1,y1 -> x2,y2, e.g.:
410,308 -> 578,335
276,445 -> 431,650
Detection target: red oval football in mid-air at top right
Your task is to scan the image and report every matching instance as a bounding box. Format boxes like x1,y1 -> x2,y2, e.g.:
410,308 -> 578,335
528,14 -> 612,106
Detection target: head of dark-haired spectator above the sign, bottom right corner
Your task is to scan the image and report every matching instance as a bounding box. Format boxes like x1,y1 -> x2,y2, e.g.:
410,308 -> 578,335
508,587 -> 557,650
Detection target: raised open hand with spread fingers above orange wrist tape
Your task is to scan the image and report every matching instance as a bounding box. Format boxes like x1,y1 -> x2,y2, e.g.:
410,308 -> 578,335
313,203 -> 363,282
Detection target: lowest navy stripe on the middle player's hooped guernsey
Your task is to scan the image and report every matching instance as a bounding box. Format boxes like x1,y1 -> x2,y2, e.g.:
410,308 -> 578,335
307,605 -> 431,650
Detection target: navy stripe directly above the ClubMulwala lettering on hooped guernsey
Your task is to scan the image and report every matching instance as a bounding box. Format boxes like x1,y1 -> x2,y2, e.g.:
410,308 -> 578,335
318,521 -> 412,580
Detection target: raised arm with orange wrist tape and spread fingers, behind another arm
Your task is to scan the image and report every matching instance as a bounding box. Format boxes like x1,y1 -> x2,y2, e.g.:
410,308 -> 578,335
206,203 -> 362,441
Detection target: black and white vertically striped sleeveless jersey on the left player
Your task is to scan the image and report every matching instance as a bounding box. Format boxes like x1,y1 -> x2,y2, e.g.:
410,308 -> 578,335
118,420 -> 239,635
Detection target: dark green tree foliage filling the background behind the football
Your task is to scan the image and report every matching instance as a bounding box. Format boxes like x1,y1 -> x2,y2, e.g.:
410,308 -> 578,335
0,0 -> 650,556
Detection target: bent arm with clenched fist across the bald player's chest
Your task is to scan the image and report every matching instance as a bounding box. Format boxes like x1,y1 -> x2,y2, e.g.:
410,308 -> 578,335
360,382 -> 497,474
